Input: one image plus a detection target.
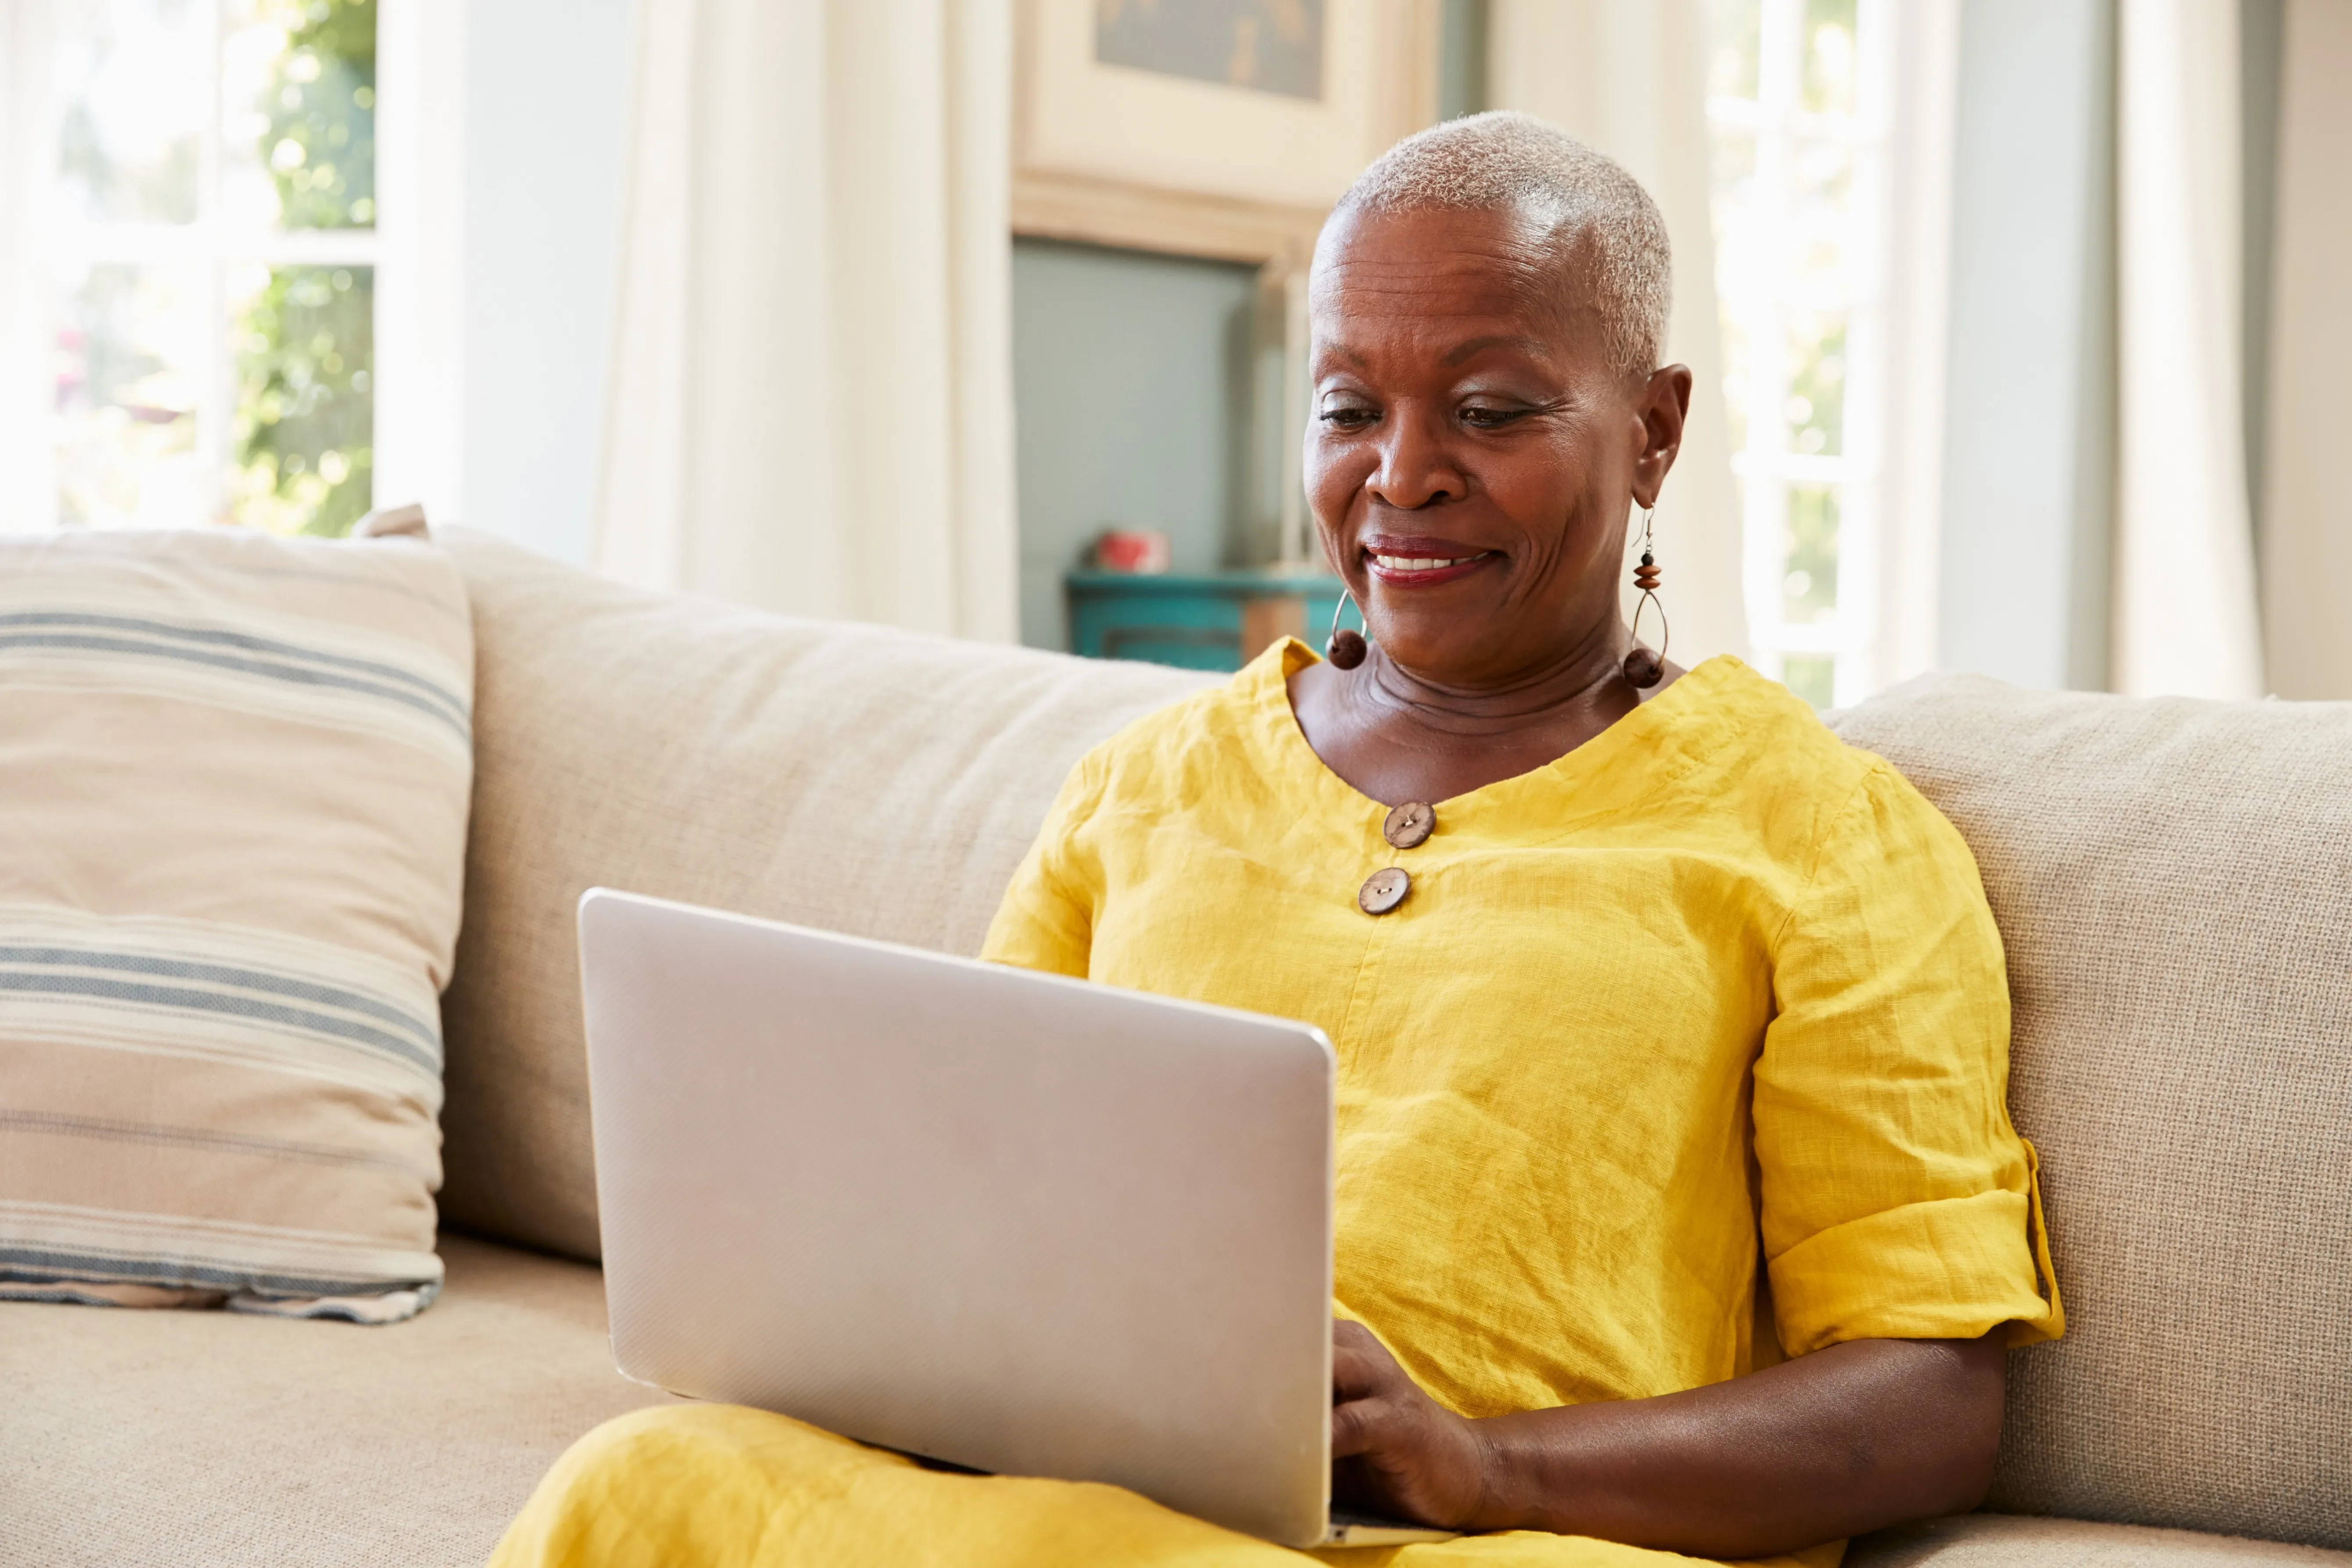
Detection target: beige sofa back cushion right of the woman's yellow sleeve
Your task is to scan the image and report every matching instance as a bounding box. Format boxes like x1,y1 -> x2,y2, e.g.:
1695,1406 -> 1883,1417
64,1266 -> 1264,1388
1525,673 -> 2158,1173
1837,677 -> 2352,1561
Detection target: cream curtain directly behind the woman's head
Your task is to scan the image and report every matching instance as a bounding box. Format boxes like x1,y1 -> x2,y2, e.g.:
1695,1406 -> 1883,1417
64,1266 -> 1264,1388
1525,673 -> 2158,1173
1487,0 -> 1747,665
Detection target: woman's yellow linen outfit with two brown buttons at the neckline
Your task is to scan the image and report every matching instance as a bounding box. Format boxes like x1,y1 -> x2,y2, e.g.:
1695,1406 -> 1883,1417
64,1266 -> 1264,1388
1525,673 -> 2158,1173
496,642 -> 2063,1568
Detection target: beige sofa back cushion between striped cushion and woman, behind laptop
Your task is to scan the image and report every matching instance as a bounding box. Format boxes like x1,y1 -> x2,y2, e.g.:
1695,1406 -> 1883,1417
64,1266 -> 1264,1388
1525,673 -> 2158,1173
442,531 -> 1209,1258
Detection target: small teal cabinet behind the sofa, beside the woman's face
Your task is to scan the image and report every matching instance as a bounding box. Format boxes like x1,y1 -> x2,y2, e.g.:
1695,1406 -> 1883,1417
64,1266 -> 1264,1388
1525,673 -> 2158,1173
1068,571 -> 1359,670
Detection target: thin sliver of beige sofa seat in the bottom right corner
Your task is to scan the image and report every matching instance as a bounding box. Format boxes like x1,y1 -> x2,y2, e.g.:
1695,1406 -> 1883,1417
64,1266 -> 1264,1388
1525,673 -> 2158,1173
1846,1514 -> 2352,1568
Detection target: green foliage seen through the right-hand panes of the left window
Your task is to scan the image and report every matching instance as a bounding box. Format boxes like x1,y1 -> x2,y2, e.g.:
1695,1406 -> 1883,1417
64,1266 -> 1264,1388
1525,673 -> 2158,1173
235,0 -> 376,536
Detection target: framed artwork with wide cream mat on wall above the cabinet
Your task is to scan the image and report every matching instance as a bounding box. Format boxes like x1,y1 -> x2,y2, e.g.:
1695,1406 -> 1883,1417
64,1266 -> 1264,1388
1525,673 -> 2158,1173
1014,0 -> 1439,268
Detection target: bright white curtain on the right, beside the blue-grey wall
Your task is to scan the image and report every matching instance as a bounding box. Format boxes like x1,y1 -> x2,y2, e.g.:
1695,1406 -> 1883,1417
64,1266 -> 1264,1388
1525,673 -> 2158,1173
2107,0 -> 2262,698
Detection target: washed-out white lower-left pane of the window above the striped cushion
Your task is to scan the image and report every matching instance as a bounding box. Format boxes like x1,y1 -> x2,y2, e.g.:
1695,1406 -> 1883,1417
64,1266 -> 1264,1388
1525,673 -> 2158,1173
54,265 -> 212,526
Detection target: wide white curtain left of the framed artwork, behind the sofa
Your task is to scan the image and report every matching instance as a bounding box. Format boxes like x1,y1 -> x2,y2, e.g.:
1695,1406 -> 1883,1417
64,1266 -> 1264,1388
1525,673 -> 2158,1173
595,0 -> 1018,642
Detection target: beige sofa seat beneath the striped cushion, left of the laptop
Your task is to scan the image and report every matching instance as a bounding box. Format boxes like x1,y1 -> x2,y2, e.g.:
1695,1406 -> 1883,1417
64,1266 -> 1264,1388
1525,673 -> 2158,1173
0,1234 -> 668,1568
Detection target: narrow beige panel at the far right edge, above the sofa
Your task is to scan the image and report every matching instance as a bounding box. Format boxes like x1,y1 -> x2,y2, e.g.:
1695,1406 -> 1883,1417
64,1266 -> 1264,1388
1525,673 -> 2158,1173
2262,0 -> 2352,701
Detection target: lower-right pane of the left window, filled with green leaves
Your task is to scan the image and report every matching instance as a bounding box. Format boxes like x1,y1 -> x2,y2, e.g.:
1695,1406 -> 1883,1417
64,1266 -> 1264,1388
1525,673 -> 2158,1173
233,268 -> 376,533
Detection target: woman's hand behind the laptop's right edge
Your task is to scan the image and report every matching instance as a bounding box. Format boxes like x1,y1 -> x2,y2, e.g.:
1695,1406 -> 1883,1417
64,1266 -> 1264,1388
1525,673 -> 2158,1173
1331,1319 -> 1489,1530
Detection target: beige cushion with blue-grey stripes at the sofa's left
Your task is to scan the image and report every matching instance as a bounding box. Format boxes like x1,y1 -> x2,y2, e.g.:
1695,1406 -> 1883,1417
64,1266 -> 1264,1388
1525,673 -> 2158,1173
0,531 -> 473,1321
